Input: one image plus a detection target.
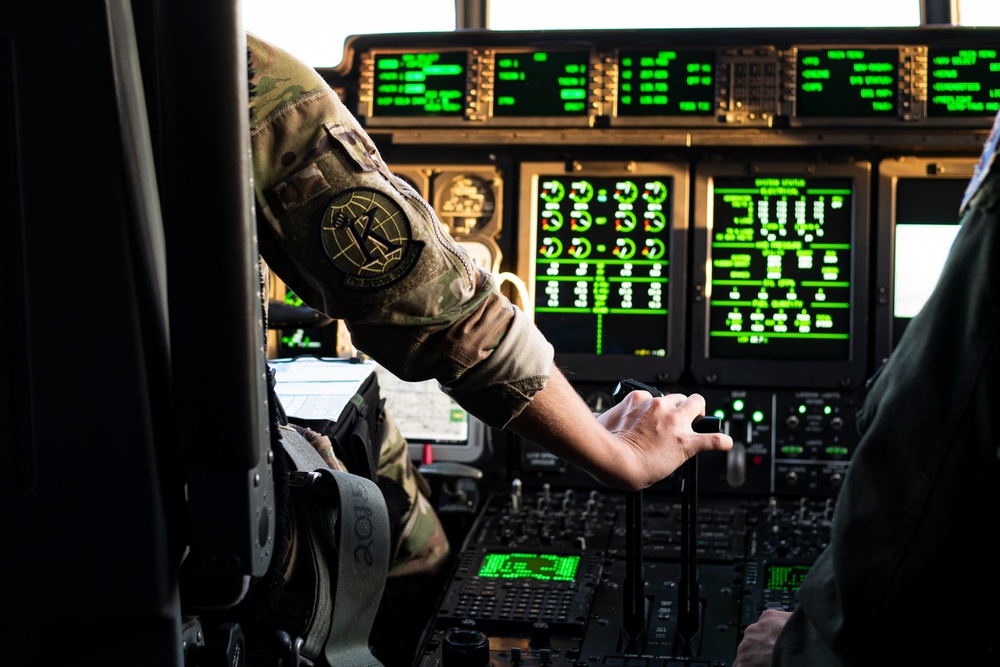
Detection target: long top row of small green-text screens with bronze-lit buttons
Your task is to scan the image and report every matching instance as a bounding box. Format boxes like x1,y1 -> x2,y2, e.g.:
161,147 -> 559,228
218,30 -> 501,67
356,29 -> 1000,129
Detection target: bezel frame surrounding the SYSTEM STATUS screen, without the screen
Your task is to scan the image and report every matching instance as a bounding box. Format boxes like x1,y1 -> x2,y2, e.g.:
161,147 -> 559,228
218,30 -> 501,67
690,161 -> 871,389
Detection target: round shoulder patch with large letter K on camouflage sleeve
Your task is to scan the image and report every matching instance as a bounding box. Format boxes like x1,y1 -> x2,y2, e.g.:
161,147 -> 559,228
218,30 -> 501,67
321,188 -> 424,290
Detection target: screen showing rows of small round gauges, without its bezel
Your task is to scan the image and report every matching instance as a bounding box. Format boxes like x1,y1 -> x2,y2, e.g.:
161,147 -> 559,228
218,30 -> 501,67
533,174 -> 673,357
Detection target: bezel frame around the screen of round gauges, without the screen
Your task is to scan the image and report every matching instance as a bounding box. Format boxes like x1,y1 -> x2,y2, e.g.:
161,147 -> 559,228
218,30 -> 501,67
517,160 -> 690,386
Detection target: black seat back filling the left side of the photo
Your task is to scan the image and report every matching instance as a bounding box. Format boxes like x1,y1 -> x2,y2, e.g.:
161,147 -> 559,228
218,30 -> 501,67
0,0 -> 274,666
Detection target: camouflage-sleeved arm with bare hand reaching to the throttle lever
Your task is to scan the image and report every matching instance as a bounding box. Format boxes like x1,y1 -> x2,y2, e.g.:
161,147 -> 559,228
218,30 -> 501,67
248,35 -> 732,489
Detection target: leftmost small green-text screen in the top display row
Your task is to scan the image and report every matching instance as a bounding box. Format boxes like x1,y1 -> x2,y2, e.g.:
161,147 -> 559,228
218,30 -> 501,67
371,51 -> 468,118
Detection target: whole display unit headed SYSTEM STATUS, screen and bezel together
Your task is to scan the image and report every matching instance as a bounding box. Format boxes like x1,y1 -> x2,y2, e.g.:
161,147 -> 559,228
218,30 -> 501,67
691,161 -> 871,389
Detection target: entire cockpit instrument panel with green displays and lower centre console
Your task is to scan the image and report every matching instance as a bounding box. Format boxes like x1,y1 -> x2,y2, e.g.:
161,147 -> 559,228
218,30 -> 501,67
314,26 -> 1000,667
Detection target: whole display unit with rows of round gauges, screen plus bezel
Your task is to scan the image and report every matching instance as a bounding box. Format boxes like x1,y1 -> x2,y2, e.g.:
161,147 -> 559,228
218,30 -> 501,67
519,163 -> 688,382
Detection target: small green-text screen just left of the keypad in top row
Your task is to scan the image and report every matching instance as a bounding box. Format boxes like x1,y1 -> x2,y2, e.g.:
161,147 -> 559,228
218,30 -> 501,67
617,49 -> 715,116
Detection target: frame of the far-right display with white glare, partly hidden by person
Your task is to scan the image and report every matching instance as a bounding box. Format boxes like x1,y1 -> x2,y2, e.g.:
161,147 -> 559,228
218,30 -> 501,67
873,155 -> 978,364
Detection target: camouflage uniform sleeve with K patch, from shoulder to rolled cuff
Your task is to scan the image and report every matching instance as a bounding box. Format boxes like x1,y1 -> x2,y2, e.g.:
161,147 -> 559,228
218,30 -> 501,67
248,35 -> 553,427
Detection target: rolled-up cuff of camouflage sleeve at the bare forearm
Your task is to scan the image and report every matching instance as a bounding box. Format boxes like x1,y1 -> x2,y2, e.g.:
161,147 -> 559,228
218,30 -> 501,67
441,306 -> 555,428
